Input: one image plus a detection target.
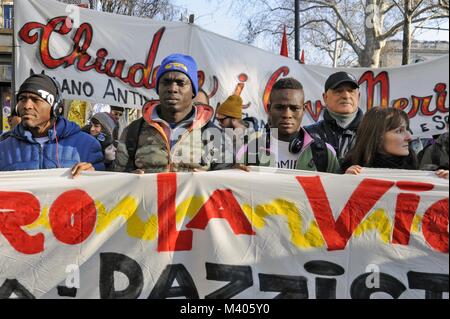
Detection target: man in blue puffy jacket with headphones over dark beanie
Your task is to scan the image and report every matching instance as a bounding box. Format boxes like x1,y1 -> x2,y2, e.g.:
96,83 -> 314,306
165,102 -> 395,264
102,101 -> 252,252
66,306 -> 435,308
0,74 -> 105,176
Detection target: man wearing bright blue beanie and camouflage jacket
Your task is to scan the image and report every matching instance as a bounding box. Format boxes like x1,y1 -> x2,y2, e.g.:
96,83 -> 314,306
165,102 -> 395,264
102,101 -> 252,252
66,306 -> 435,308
114,53 -> 232,173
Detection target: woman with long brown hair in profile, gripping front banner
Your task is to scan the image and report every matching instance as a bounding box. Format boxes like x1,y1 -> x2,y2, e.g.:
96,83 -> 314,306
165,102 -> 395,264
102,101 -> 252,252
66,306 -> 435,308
342,107 -> 449,178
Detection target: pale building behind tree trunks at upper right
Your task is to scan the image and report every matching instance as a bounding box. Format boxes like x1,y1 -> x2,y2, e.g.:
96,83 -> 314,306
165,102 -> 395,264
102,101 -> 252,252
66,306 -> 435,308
380,40 -> 449,67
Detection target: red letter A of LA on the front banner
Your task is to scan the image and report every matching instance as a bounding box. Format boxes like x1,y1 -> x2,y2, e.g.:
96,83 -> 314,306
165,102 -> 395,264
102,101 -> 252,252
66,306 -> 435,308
186,189 -> 255,235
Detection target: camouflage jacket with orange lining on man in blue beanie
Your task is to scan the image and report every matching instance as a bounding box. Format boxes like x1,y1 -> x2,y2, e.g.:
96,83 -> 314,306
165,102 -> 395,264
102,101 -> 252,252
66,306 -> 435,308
114,103 -> 230,173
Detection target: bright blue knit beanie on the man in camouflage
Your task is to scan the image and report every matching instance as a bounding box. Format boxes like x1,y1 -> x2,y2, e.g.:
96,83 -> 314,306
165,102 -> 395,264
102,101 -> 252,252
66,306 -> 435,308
156,53 -> 198,97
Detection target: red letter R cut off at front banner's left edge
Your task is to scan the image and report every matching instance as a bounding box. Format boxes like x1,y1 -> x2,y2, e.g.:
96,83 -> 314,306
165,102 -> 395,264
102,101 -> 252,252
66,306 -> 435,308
0,191 -> 44,255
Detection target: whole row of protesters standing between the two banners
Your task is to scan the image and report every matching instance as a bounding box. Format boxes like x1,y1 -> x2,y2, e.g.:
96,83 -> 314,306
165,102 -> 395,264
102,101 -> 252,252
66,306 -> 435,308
0,54 -> 449,179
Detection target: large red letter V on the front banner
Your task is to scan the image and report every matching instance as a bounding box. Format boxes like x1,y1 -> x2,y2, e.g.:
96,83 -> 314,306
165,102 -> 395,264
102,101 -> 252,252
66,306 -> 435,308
296,176 -> 394,250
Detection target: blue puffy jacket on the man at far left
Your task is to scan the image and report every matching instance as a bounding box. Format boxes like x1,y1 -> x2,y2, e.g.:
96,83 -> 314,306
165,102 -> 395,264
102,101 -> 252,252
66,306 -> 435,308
0,117 -> 105,171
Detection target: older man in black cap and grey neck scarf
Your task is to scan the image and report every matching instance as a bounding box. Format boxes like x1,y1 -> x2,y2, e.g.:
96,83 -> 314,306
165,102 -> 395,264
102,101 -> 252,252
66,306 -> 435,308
305,72 -> 363,163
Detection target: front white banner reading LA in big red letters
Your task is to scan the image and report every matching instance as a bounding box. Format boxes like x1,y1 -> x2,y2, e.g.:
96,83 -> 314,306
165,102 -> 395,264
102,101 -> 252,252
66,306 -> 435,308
0,168 -> 449,299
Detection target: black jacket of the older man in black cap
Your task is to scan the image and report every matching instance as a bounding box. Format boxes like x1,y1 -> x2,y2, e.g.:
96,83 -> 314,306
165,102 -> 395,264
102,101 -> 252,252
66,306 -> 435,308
305,108 -> 364,163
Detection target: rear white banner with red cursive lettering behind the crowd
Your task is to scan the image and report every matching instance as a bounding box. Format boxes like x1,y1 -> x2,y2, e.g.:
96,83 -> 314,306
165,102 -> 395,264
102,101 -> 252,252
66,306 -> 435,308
14,0 -> 449,137
